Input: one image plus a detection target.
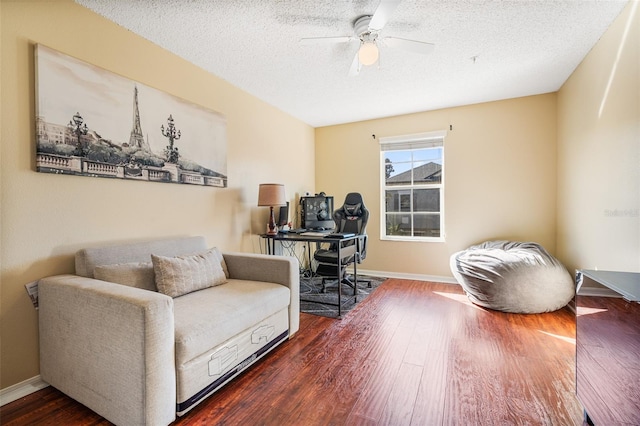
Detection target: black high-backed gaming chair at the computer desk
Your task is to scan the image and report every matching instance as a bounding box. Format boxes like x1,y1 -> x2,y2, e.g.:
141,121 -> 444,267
313,192 -> 371,292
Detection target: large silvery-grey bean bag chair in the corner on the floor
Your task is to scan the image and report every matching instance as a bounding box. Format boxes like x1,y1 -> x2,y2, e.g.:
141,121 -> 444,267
450,241 -> 575,314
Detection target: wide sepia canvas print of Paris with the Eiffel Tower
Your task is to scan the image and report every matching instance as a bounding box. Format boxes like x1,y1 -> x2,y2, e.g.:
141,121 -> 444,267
35,44 -> 227,188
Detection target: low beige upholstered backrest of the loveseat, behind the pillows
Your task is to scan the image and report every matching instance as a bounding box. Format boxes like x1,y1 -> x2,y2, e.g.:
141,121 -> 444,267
76,236 -> 207,278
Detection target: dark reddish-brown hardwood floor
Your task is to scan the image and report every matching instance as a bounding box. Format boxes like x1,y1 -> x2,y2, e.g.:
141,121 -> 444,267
0,279 -> 582,426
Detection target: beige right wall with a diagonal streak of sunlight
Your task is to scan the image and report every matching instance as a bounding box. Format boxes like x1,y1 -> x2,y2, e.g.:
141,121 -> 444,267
558,1 -> 640,272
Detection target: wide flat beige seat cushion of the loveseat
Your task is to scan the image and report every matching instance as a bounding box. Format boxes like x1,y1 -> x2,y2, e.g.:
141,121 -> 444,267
173,278 -> 291,365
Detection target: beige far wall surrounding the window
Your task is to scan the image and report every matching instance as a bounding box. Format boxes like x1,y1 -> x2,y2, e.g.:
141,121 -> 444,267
316,94 -> 556,277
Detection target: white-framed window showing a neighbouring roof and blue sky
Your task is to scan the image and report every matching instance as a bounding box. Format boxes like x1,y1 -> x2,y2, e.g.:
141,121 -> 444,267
380,131 -> 446,241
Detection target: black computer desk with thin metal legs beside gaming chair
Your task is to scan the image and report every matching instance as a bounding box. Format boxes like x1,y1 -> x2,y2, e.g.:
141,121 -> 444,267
261,232 -> 361,318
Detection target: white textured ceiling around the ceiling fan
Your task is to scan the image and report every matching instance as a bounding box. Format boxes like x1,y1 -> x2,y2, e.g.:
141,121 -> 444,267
76,0 -> 627,127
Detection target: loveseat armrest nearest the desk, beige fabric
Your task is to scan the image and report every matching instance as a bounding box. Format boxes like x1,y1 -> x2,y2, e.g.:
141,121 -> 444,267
223,253 -> 300,338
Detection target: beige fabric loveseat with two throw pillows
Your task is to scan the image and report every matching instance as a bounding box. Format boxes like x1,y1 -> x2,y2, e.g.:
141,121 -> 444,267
39,237 -> 300,425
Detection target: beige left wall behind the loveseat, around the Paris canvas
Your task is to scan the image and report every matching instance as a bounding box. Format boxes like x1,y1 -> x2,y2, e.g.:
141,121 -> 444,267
0,0 -> 314,388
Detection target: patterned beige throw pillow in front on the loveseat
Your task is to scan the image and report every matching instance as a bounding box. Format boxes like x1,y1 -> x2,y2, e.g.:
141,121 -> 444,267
151,249 -> 227,297
